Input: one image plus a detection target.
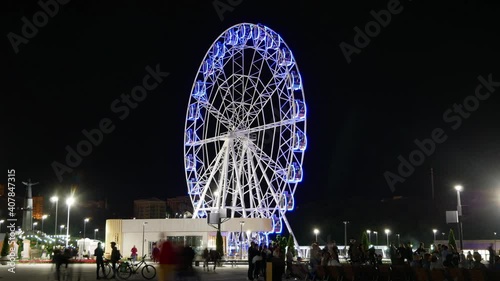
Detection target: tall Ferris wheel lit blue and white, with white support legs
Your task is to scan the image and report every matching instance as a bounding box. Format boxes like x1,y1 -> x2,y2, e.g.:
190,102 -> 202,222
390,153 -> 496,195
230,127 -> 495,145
184,23 -> 307,241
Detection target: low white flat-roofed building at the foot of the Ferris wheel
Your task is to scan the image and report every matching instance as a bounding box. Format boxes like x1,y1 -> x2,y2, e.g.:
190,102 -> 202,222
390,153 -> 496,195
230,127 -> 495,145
104,218 -> 273,258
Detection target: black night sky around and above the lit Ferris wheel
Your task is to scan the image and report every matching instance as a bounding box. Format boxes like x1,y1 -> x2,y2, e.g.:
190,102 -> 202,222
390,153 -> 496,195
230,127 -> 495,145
0,0 -> 500,241
